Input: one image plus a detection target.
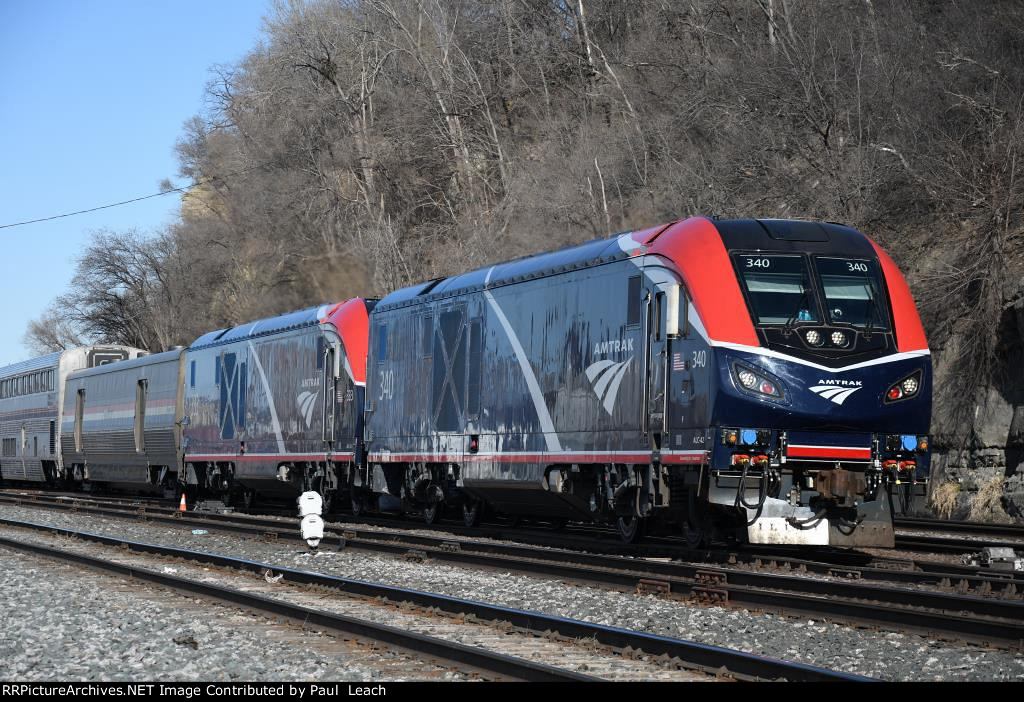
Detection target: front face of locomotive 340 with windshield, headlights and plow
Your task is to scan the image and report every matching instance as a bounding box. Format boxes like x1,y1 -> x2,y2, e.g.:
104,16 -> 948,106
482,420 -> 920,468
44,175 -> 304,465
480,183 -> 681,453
688,220 -> 931,546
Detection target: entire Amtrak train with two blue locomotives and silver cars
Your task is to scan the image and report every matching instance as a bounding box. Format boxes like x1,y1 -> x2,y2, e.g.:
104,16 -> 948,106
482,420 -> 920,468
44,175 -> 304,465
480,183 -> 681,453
0,217 -> 932,547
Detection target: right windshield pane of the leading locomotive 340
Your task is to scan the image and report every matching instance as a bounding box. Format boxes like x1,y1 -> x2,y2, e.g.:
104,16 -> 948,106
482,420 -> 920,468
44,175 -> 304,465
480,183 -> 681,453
817,258 -> 889,328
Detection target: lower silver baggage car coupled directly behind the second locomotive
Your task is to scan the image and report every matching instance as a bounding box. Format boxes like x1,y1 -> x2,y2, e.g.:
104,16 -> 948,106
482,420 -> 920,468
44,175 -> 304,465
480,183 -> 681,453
61,349 -> 184,494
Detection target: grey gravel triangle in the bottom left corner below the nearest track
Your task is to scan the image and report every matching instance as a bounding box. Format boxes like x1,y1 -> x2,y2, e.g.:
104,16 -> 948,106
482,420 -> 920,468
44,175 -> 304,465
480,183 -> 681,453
0,549 -> 464,682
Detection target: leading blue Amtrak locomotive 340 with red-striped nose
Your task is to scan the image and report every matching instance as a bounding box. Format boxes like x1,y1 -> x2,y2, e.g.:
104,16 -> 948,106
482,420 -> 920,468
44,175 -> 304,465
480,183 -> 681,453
360,218 -> 932,546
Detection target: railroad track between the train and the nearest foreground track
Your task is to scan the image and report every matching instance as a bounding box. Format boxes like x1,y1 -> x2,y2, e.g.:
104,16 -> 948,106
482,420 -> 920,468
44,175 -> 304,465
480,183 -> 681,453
0,497 -> 1024,648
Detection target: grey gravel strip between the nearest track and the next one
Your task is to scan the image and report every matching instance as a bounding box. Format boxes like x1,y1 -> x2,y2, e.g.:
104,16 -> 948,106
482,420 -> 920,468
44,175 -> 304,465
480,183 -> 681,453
0,504 -> 1024,681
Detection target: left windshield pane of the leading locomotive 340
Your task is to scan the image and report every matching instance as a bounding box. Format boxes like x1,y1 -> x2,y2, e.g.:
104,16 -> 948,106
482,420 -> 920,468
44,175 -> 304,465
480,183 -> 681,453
735,254 -> 818,324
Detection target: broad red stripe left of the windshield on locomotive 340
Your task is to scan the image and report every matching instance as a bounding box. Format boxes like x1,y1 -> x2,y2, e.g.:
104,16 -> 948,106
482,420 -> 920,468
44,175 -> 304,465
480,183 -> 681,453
631,217 -> 761,346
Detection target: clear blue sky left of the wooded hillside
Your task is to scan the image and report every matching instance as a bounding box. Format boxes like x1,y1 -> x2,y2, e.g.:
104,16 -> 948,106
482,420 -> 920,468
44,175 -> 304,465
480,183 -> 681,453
0,0 -> 270,365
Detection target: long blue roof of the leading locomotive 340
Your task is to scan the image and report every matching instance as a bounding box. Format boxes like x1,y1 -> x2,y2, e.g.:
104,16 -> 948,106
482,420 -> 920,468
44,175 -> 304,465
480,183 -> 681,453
377,234 -> 629,309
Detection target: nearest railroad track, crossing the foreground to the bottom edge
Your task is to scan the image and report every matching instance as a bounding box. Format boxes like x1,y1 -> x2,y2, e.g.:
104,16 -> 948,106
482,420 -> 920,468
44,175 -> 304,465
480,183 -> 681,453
0,520 -> 867,682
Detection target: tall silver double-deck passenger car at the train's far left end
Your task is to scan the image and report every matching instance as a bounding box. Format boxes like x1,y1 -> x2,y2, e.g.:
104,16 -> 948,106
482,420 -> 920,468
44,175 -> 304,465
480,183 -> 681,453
0,346 -> 145,483
